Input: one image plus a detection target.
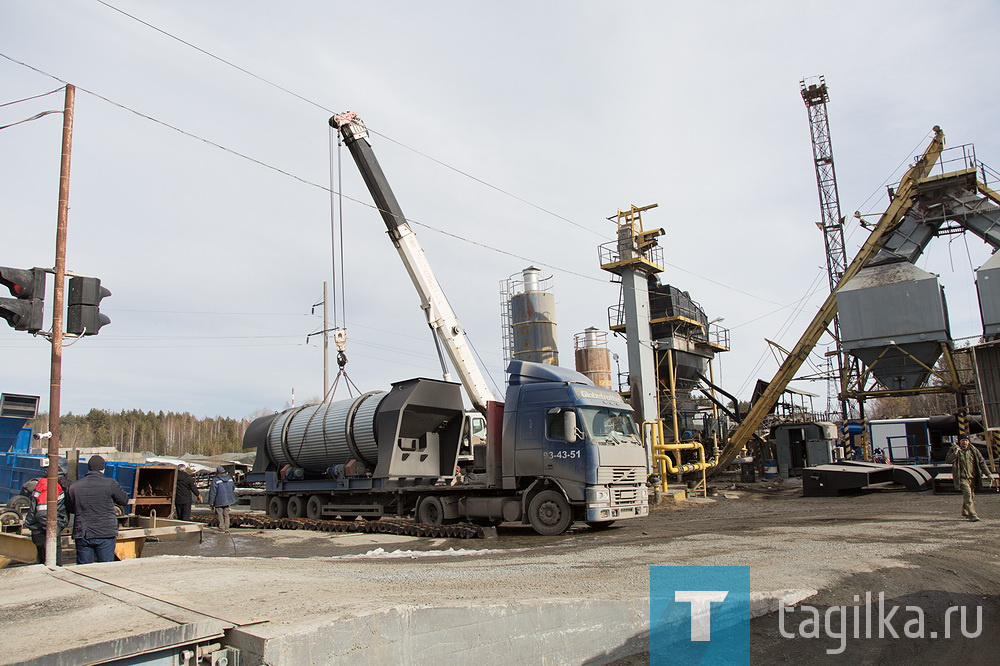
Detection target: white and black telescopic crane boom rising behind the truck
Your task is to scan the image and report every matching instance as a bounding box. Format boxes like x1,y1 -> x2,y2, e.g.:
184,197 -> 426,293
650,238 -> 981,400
330,112 -> 497,415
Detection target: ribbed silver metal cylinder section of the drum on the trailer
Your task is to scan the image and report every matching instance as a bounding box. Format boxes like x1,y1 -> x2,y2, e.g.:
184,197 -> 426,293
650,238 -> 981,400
267,391 -> 388,473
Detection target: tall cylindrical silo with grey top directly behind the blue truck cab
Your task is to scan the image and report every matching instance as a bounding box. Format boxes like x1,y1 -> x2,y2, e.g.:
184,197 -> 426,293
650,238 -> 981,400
504,267 -> 559,365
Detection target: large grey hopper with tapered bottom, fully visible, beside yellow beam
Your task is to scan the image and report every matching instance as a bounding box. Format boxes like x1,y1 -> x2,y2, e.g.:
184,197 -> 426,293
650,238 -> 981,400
837,261 -> 950,390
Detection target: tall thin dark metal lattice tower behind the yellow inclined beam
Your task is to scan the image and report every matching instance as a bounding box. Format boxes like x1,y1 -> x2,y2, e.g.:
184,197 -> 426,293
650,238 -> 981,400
799,76 -> 850,419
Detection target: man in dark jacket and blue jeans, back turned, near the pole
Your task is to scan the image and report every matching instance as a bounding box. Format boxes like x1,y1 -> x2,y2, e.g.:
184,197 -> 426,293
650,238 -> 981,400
67,456 -> 128,564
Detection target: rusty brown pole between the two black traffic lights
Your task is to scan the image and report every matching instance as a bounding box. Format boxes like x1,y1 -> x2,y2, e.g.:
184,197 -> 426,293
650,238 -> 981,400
45,83 -> 78,567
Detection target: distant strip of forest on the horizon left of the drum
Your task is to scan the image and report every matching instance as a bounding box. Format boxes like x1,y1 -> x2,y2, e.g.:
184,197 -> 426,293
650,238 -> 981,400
29,409 -> 271,456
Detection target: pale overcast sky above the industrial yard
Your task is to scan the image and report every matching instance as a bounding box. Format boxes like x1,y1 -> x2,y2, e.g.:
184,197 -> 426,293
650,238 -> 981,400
0,0 -> 1000,417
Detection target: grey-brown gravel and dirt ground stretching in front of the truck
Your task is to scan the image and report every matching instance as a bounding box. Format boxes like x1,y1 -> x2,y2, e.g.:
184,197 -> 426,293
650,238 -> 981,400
0,483 -> 1000,665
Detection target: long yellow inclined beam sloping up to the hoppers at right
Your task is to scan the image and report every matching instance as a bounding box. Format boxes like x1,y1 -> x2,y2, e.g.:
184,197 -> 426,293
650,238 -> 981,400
715,126 -> 944,470
